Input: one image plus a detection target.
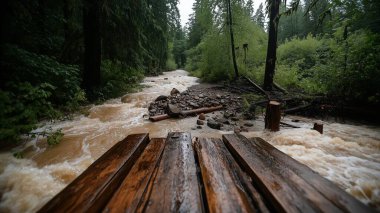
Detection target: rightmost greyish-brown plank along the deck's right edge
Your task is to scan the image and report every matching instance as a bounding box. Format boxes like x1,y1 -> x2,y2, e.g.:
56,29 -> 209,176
250,138 -> 374,213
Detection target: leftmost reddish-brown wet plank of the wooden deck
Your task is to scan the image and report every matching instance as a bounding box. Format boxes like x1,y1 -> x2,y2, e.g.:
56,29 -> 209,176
39,134 -> 149,212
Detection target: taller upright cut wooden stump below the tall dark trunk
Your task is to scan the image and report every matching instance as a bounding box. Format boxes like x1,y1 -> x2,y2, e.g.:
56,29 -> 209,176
265,101 -> 281,132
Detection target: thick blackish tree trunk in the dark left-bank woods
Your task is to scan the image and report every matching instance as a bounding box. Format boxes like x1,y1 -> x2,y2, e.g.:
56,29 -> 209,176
83,0 -> 101,98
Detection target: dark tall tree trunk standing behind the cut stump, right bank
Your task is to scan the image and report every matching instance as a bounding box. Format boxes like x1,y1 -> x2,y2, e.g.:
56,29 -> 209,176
264,0 -> 281,91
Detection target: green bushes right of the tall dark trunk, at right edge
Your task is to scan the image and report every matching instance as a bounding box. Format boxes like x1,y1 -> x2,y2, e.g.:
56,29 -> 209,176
275,28 -> 380,100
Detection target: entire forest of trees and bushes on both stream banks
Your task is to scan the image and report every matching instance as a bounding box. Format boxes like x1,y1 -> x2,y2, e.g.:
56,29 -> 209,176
0,0 -> 380,144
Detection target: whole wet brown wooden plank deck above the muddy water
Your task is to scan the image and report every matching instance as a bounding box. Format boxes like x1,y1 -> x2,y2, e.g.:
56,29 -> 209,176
39,133 -> 374,213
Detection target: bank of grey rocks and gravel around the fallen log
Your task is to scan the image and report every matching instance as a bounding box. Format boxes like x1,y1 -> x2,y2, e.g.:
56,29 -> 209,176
149,84 -> 262,132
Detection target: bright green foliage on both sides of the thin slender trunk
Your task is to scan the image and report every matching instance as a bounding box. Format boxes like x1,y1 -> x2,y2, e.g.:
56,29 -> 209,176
186,3 -> 267,82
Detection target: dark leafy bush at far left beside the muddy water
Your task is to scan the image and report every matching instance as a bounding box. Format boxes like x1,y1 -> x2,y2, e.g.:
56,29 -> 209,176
0,45 -> 85,143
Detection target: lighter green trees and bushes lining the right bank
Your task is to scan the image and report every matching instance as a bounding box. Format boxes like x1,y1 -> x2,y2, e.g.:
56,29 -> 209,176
186,0 -> 380,100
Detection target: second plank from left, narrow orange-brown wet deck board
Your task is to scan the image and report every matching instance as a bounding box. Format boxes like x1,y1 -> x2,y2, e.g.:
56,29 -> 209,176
103,138 -> 165,213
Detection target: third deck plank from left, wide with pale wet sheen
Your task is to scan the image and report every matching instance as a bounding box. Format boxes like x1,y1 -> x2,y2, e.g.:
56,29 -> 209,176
144,132 -> 202,212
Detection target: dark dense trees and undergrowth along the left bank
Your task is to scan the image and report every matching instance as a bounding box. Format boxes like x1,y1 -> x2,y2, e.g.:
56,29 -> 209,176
0,0 -> 185,143
